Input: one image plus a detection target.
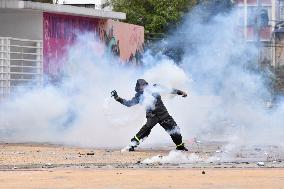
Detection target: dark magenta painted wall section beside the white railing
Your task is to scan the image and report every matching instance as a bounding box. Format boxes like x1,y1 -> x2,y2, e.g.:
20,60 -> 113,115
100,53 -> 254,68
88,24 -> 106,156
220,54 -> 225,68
43,13 -> 99,75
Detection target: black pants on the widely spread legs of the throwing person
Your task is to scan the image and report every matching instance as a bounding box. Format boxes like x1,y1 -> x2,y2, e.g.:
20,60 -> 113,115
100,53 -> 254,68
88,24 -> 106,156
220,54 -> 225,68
131,115 -> 182,147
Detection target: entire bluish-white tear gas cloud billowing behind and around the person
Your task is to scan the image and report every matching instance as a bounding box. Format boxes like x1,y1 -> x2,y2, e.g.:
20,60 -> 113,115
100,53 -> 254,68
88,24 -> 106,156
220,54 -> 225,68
0,4 -> 284,153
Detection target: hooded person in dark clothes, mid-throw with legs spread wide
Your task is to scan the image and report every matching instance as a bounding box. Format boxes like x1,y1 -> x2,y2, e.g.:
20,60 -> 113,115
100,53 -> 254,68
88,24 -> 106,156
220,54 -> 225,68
111,79 -> 188,151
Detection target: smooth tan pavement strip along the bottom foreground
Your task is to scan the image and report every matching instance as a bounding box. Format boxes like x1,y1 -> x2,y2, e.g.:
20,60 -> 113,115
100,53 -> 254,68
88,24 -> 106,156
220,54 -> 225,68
0,169 -> 284,189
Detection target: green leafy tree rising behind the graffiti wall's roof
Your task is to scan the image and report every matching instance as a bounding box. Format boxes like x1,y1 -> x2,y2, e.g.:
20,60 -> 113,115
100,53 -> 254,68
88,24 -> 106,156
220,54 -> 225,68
109,0 -> 196,34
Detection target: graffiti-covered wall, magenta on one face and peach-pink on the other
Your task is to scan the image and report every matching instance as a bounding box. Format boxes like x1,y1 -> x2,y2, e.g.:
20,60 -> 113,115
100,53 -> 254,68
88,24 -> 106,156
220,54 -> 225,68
43,13 -> 144,79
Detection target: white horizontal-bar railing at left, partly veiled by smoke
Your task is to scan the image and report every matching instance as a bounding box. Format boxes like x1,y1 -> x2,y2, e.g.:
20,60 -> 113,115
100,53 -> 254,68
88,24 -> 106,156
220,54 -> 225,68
0,37 -> 43,100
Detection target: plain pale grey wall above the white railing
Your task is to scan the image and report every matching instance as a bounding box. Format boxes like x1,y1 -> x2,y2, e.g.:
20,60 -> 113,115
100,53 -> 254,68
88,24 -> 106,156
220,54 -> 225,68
0,9 -> 43,40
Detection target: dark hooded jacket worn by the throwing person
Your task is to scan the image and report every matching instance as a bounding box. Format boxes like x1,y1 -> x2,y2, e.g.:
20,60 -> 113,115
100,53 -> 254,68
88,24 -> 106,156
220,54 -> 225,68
116,79 -> 182,119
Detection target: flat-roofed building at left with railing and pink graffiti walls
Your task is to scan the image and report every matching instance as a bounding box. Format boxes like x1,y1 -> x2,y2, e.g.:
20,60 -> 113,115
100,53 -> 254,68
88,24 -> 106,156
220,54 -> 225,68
0,0 -> 144,100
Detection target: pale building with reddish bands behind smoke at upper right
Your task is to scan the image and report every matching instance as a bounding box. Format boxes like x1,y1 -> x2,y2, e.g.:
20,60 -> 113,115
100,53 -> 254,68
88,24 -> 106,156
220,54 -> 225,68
235,0 -> 284,68
